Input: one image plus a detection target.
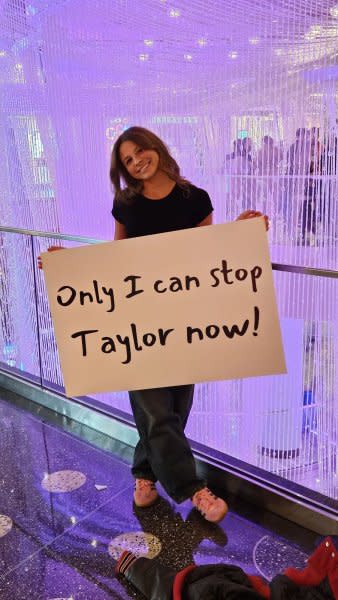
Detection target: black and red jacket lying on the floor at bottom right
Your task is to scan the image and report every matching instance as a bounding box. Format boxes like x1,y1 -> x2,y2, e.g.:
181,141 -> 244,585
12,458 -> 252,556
116,538 -> 338,600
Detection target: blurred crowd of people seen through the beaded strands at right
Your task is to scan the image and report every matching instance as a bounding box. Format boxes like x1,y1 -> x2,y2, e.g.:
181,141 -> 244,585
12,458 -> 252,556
224,127 -> 338,245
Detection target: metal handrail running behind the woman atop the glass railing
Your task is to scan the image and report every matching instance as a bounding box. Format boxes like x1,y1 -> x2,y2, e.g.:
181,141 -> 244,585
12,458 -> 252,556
0,225 -> 338,279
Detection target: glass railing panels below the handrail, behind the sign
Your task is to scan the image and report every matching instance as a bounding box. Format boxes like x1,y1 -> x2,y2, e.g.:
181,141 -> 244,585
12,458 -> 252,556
0,227 -> 338,510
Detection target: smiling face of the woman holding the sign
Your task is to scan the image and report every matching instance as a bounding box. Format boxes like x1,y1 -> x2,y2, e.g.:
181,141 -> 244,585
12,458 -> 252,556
120,141 -> 160,181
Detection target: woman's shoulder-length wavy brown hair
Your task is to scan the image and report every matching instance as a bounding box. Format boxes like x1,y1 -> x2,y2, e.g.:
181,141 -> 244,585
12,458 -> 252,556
109,127 -> 189,202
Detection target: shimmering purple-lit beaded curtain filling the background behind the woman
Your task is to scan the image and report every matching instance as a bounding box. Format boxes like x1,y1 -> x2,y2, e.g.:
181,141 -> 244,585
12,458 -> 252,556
0,0 -> 338,497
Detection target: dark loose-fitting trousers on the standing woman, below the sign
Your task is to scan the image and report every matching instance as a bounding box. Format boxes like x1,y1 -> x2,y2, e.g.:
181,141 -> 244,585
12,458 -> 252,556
129,386 -> 205,502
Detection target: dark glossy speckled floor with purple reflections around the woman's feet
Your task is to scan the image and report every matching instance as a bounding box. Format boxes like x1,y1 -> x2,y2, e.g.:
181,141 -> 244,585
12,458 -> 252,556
0,391 -> 332,600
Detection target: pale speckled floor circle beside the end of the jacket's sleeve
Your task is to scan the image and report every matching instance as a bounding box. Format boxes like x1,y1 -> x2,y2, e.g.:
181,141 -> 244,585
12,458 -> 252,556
108,531 -> 162,560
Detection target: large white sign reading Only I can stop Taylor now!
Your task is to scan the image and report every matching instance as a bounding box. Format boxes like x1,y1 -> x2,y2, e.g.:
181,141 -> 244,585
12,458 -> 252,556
42,218 -> 286,396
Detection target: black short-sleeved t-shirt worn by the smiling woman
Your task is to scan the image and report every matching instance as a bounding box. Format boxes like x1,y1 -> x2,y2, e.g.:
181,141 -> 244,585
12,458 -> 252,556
112,184 -> 213,238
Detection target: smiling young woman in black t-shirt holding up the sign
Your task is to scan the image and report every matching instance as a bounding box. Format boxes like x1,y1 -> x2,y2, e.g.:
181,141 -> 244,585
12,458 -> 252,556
110,127 -> 268,522
